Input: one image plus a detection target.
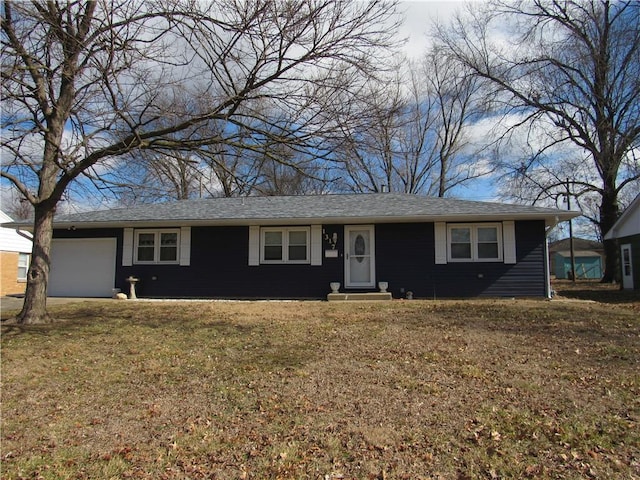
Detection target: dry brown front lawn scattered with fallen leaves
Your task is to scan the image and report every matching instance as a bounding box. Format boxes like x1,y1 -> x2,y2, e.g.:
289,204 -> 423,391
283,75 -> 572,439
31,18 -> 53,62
1,284 -> 640,480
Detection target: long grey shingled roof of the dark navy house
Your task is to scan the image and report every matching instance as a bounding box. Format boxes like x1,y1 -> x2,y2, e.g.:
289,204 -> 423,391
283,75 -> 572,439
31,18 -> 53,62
5,193 -> 579,228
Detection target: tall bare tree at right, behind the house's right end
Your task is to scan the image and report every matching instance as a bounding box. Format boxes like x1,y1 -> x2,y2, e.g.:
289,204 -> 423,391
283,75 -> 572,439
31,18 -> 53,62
439,0 -> 640,281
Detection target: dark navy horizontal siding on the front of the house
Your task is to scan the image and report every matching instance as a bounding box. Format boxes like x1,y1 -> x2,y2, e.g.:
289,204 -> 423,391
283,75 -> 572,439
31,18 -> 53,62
54,221 -> 545,298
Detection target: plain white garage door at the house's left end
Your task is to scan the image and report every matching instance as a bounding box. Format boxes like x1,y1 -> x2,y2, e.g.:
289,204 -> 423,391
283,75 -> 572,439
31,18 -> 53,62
49,238 -> 116,297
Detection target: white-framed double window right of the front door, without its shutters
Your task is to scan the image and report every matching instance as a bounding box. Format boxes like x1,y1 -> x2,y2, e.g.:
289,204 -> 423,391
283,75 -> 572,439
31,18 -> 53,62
447,223 -> 502,262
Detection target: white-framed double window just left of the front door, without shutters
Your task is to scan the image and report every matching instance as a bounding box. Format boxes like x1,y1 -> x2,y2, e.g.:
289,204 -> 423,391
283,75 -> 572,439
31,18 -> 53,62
260,227 -> 310,263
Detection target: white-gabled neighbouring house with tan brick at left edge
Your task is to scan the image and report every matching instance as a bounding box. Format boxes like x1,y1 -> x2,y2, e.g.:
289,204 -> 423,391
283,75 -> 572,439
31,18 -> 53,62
0,211 -> 31,296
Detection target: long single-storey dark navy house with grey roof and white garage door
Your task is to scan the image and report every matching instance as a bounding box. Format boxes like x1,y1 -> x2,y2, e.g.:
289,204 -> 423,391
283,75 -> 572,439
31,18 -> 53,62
2,193 -> 579,298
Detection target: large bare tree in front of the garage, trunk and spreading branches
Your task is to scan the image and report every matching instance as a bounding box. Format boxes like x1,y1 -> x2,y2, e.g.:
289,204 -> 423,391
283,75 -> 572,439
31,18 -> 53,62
0,0 -> 395,323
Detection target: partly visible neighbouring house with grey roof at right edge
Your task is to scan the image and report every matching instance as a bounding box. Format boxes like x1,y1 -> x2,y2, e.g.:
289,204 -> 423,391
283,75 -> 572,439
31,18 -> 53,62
604,195 -> 640,290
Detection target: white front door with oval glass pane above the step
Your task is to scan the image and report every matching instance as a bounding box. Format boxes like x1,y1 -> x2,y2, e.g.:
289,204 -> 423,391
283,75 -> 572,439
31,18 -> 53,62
344,225 -> 376,288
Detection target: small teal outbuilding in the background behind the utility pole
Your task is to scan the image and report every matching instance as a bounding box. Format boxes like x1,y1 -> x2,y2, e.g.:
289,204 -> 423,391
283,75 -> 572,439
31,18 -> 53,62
549,238 -> 604,280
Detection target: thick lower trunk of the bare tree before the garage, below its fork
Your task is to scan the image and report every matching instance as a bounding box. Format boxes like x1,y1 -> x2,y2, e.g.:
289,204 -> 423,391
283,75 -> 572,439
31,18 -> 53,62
17,202 -> 55,324
